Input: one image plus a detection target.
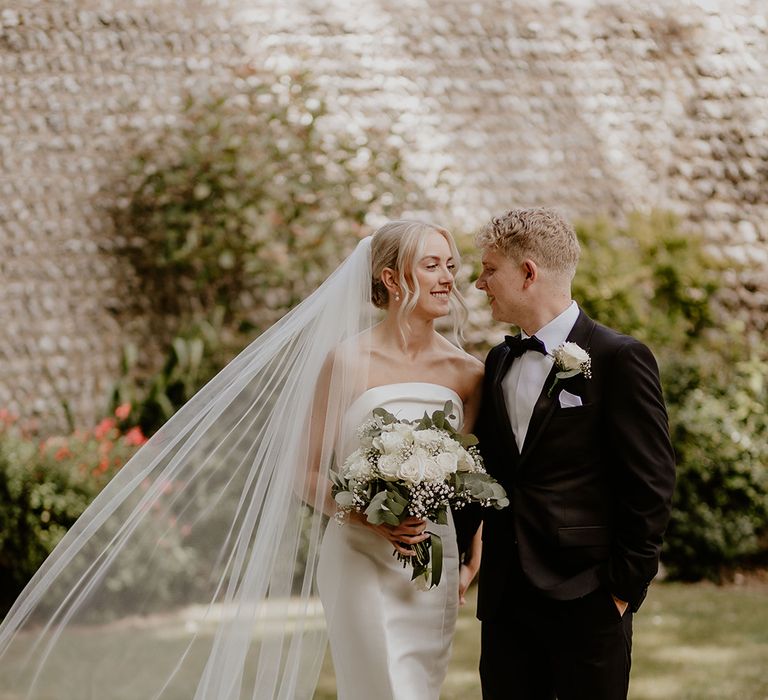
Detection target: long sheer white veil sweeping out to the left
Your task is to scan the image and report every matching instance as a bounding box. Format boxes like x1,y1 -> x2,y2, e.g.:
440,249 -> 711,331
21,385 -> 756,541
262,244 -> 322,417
0,238 -> 373,700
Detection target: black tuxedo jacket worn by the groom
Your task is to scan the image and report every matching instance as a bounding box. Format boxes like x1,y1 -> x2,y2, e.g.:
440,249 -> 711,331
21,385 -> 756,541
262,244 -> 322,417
475,311 -> 675,619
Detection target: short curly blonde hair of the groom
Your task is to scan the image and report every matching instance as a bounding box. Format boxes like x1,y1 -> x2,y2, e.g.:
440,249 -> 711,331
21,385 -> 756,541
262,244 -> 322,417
475,207 -> 581,279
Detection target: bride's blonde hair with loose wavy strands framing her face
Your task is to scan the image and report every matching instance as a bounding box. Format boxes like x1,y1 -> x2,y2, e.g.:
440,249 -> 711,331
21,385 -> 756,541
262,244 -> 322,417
371,219 -> 469,340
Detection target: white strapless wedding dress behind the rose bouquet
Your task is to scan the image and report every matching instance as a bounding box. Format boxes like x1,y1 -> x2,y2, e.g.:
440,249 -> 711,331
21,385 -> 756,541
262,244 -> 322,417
318,382 -> 463,700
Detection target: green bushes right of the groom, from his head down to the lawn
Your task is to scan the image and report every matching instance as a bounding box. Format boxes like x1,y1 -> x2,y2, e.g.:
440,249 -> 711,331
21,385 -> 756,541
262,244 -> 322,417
574,212 -> 768,580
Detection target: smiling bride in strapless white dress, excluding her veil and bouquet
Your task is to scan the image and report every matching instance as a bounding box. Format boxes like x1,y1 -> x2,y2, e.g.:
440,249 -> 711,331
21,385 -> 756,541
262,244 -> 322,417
318,221 -> 483,700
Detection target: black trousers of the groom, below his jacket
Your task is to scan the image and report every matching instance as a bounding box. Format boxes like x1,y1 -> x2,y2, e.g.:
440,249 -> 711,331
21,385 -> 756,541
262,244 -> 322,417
480,588 -> 632,700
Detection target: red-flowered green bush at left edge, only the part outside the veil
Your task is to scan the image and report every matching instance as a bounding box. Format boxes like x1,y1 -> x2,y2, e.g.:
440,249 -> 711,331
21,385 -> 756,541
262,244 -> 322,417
0,406 -> 145,607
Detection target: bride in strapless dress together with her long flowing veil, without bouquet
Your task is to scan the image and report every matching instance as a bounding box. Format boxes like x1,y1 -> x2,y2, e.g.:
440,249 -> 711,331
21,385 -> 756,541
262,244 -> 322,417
0,221 -> 482,700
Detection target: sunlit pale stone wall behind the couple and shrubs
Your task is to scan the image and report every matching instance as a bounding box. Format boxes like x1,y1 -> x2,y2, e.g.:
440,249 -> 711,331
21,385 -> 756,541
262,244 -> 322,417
0,0 -> 768,430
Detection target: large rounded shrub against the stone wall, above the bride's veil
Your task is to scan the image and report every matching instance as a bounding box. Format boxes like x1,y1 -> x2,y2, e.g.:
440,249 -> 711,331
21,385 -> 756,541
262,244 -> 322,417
116,71 -> 419,329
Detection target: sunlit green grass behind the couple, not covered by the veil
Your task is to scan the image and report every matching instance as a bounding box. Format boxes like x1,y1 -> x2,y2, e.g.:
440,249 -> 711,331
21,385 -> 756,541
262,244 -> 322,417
315,583 -> 768,700
